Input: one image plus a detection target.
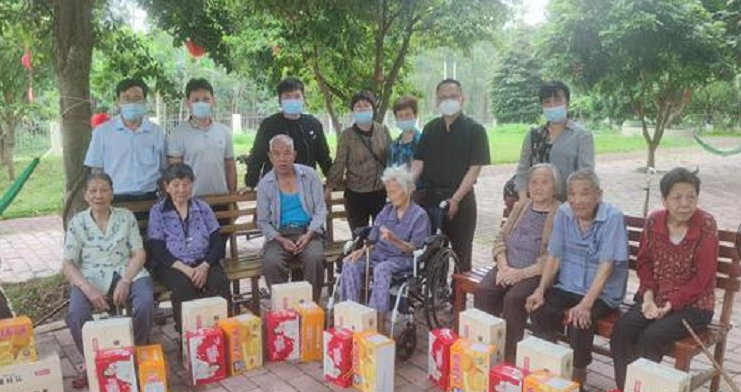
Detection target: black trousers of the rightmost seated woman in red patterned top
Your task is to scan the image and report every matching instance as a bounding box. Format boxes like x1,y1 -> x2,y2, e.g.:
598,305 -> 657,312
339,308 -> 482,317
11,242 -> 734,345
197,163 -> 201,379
610,302 -> 713,390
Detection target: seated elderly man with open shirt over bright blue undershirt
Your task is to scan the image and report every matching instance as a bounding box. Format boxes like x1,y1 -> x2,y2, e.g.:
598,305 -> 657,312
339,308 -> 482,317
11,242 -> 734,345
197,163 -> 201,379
257,135 -> 327,301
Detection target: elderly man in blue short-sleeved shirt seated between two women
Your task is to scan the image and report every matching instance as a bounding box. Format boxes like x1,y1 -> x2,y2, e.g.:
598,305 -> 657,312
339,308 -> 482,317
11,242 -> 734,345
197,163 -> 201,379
525,169 -> 628,385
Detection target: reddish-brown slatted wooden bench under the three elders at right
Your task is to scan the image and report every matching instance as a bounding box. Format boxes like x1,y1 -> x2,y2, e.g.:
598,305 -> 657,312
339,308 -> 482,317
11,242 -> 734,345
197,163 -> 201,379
453,216 -> 741,392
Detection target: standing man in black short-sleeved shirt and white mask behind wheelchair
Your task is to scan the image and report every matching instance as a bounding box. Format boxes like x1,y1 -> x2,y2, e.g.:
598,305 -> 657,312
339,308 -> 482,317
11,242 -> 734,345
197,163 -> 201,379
412,79 -> 491,271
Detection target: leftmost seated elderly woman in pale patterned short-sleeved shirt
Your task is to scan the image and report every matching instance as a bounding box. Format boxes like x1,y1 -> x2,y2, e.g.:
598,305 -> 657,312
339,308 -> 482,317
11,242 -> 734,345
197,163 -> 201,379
62,173 -> 154,389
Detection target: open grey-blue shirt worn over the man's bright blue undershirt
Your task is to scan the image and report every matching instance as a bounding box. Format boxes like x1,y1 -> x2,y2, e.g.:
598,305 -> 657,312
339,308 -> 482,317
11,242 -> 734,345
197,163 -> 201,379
257,164 -> 327,242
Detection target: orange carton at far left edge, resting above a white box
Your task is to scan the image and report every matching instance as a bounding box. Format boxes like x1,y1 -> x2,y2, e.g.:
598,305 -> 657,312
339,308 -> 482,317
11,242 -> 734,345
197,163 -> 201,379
0,316 -> 38,366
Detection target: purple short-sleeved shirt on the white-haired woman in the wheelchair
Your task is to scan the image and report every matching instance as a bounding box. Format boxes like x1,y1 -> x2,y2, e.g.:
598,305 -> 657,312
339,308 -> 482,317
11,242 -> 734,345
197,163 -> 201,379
368,201 -> 430,261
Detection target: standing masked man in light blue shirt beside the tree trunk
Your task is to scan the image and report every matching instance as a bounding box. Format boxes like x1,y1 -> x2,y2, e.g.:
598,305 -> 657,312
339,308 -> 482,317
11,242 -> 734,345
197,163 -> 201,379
85,79 -> 167,203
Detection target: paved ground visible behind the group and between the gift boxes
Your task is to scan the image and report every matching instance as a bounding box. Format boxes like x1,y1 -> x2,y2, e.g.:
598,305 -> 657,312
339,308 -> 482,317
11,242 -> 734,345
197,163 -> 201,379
0,142 -> 741,392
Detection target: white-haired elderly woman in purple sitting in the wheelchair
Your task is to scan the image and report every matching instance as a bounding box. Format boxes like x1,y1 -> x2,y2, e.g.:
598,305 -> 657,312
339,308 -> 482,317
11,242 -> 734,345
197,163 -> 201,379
340,166 -> 430,315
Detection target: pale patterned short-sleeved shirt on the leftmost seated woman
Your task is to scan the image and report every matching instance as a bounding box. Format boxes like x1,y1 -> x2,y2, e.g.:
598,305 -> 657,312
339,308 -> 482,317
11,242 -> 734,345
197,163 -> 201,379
64,207 -> 149,293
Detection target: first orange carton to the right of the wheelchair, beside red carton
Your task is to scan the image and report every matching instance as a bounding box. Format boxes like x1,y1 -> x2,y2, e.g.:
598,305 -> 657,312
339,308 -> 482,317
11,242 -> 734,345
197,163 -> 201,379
450,338 -> 496,392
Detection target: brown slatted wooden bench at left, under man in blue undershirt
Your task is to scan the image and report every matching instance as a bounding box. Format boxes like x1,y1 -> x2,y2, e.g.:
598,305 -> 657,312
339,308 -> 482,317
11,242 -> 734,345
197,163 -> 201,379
115,192 -> 346,314
